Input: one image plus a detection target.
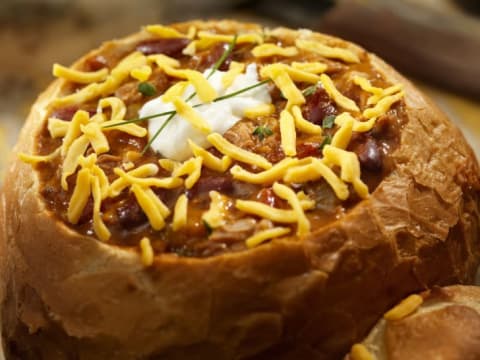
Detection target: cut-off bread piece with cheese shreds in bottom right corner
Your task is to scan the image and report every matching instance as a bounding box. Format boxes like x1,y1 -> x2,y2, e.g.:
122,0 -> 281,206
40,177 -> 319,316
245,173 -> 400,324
347,285 -> 480,360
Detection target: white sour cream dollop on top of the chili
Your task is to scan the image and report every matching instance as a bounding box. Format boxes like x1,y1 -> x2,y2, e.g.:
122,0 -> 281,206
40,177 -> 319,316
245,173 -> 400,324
139,64 -> 272,161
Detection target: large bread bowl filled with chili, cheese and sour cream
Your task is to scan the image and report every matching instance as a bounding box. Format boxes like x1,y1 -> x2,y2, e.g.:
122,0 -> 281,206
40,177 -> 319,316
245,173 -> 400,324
0,21 -> 479,359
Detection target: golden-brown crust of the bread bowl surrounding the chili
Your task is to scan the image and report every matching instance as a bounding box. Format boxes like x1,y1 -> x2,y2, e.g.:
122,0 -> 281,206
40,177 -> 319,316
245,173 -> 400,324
0,21 -> 480,359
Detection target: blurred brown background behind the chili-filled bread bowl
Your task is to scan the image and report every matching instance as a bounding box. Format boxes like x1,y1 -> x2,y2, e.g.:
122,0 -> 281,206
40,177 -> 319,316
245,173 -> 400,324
0,0 -> 480,180
